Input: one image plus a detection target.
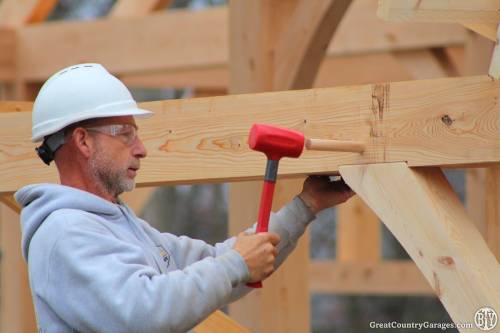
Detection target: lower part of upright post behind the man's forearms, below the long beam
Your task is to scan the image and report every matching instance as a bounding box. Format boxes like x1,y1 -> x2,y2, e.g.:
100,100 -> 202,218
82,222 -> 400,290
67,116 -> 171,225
228,178 -> 310,332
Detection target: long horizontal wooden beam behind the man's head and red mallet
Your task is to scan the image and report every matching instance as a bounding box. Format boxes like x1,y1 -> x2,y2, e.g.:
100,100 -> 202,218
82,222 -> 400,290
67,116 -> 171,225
0,76 -> 500,192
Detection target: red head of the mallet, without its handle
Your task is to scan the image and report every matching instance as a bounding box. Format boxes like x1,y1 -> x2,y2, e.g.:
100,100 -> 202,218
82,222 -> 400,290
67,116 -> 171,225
248,124 -> 305,161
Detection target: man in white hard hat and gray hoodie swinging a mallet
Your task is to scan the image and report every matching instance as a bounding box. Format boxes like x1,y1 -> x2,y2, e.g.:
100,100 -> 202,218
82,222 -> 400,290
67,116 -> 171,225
16,64 -> 352,332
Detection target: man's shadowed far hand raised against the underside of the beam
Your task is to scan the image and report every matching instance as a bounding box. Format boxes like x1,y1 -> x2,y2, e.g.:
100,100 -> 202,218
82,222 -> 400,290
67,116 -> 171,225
299,176 -> 355,214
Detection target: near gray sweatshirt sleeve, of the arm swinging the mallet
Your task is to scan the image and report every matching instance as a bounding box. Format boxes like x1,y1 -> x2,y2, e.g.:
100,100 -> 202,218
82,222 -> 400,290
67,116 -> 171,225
45,215 -> 250,332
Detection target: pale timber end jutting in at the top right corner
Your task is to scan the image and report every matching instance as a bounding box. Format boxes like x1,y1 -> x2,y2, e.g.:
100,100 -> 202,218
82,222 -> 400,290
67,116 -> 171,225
377,0 -> 500,23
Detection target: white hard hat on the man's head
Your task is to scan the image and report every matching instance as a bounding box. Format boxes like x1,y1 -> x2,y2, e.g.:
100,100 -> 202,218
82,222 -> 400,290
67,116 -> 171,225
31,64 -> 153,142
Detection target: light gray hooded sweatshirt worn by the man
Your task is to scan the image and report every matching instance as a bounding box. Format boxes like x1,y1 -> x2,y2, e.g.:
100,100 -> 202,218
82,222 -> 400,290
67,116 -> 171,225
15,184 -> 314,333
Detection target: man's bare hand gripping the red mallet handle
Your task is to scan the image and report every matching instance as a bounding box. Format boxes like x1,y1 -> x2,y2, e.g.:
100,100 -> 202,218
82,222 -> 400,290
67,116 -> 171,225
233,232 -> 280,282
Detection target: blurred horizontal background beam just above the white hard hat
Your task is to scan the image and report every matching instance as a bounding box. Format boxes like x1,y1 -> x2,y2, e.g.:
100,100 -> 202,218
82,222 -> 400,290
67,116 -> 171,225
15,8 -> 228,80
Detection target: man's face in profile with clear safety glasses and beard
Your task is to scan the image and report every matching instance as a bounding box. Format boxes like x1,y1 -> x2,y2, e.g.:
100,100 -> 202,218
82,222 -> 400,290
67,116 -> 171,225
87,116 -> 147,197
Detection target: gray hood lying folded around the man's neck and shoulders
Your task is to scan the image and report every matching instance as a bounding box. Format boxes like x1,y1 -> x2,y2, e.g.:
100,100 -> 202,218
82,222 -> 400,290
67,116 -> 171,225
14,184 -> 121,260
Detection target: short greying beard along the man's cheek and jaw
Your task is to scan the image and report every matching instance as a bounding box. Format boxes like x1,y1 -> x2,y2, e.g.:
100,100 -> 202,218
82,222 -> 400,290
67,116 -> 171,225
89,144 -> 135,197
